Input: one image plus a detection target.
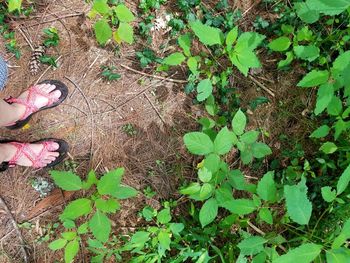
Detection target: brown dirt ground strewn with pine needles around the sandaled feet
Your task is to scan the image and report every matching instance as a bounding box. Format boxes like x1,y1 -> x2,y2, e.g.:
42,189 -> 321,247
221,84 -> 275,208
0,0 -> 314,263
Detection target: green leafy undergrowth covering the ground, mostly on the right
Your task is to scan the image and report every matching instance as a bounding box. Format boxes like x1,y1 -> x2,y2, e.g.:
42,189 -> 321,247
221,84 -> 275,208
0,0 -> 350,263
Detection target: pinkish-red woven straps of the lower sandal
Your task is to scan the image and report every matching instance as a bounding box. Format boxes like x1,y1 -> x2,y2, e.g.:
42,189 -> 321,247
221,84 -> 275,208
9,141 -> 55,168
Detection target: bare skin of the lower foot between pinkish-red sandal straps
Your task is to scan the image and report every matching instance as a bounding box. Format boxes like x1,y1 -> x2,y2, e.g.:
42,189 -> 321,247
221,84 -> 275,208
0,143 -> 60,167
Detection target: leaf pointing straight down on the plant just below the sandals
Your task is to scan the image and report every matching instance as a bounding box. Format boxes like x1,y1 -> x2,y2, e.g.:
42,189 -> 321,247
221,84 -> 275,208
89,210 -> 111,243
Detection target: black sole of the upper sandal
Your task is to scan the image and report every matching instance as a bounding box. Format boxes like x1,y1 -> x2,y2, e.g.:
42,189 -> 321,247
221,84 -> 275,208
6,80 -> 69,130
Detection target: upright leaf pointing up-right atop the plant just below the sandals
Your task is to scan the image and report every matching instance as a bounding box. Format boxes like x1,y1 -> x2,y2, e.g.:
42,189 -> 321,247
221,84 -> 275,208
97,168 -> 124,195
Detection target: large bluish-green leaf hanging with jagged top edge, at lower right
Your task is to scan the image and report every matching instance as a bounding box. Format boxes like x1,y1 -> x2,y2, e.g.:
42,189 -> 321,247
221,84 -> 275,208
284,178 -> 312,225
